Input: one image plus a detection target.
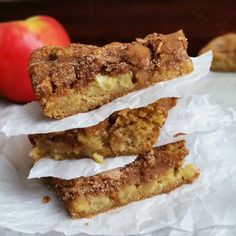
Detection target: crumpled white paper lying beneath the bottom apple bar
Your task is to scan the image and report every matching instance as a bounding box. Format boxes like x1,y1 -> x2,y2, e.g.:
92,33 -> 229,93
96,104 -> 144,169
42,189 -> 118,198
0,123 -> 236,235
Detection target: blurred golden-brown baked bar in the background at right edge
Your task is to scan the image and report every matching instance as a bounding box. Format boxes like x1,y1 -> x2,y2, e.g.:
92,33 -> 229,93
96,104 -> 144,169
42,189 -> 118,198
199,33 -> 236,71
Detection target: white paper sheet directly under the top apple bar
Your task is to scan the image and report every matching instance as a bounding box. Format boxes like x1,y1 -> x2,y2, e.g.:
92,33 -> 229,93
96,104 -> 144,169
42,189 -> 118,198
1,52 -> 212,136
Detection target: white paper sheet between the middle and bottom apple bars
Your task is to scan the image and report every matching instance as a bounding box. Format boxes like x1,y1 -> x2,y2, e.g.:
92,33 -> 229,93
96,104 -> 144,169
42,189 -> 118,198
29,95 -> 236,179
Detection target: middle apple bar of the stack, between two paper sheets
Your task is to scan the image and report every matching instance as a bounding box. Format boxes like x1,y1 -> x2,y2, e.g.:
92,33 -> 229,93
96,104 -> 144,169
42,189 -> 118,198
29,97 -> 177,162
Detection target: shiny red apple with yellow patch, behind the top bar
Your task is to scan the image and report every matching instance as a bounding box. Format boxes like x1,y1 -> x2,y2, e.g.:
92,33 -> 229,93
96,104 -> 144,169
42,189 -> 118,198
0,16 -> 70,102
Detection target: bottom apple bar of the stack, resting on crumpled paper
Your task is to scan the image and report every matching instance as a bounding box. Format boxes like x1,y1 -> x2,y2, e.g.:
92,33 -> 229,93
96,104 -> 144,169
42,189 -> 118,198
45,141 -> 199,218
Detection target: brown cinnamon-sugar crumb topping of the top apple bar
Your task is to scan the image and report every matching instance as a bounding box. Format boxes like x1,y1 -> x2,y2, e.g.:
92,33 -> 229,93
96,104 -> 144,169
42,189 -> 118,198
29,31 -> 188,99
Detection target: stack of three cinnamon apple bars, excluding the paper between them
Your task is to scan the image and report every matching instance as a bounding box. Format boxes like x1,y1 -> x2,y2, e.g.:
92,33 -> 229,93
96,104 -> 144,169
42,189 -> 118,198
29,31 -> 199,218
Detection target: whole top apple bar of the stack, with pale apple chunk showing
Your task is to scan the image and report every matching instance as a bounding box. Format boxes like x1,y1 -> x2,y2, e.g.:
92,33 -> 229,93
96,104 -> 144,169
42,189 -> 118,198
29,30 -> 193,119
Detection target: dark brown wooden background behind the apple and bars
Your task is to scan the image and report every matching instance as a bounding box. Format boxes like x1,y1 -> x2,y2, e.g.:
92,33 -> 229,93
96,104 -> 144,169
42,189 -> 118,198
0,0 -> 236,56
